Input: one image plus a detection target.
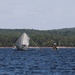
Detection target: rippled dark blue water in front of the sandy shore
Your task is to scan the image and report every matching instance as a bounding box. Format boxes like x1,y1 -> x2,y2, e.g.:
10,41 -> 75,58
0,48 -> 75,75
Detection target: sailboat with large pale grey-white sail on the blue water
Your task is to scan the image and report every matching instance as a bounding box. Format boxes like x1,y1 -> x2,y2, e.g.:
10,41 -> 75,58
16,33 -> 30,50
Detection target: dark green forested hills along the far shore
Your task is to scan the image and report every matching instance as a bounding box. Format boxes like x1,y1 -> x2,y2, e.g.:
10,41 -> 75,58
0,28 -> 75,47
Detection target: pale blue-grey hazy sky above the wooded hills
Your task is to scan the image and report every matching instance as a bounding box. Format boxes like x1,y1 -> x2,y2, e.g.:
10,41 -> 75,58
0,0 -> 75,30
